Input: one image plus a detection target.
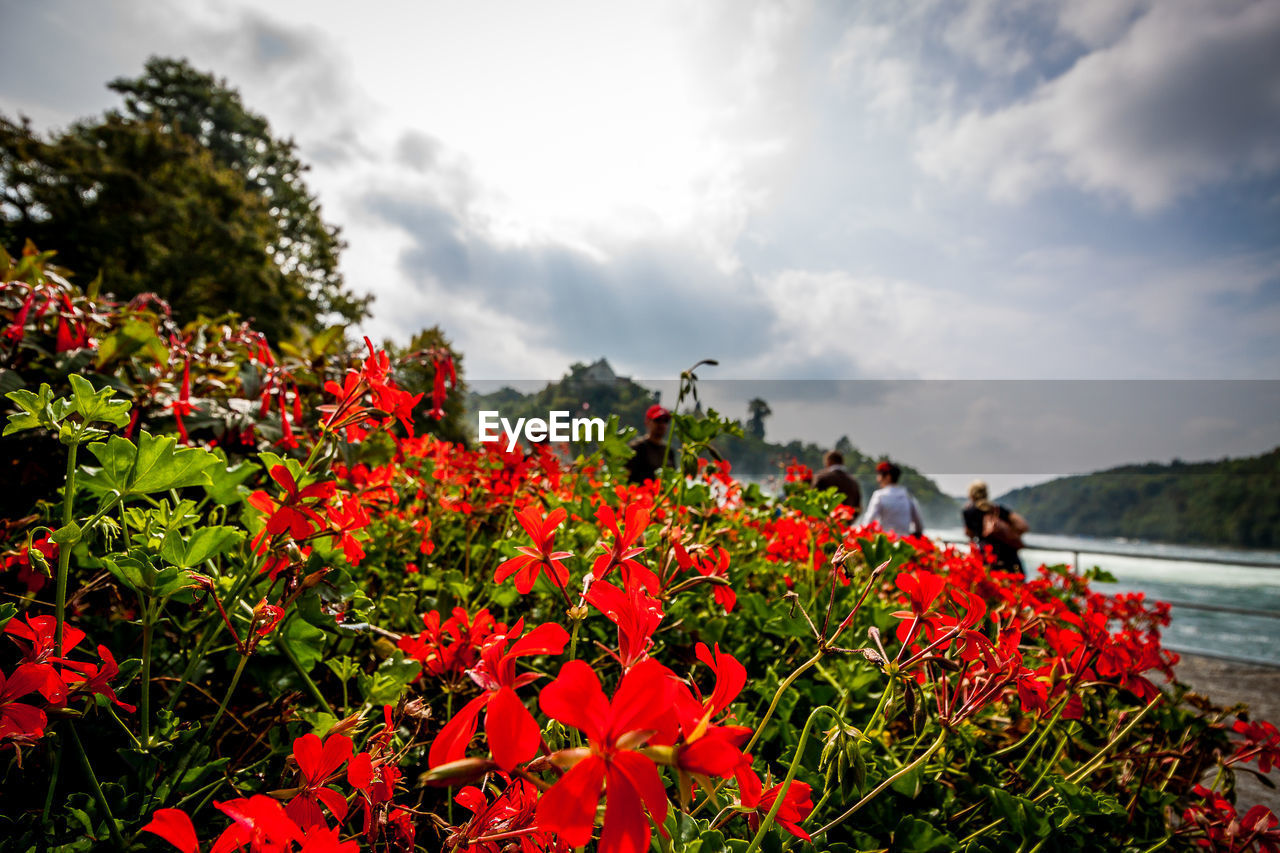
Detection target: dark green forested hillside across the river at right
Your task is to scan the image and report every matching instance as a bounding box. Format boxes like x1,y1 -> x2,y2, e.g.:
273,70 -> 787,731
1000,448 -> 1280,548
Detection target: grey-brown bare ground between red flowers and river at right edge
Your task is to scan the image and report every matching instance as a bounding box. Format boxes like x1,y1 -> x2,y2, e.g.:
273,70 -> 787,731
1176,654 -> 1280,815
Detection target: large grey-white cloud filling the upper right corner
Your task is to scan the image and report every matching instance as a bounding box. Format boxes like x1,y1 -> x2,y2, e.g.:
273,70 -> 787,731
916,0 -> 1280,211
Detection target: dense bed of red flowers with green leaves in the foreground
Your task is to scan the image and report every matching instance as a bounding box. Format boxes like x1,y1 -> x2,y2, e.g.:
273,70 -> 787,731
0,240 -> 1280,853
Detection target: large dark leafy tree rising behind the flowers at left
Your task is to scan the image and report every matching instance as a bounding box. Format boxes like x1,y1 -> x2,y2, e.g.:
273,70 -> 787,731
0,58 -> 370,339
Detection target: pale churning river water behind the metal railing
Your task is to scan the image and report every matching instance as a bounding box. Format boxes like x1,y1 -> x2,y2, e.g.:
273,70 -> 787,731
927,529 -> 1280,666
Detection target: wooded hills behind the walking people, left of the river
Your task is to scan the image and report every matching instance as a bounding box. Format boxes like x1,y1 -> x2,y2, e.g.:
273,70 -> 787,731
467,359 -> 960,526
